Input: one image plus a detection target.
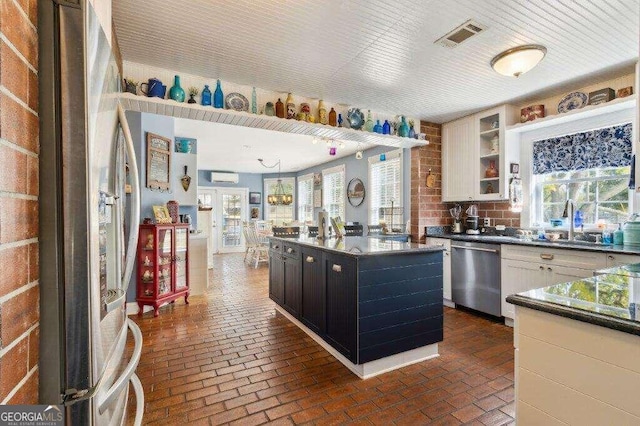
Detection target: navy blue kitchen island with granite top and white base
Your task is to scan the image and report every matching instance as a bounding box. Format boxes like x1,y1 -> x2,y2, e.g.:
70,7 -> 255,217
269,237 -> 443,378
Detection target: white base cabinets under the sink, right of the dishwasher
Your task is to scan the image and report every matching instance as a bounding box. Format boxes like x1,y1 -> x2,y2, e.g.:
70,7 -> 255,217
500,244 -> 607,319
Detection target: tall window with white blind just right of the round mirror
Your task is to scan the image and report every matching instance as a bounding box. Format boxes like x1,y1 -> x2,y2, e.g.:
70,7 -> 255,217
367,149 -> 402,225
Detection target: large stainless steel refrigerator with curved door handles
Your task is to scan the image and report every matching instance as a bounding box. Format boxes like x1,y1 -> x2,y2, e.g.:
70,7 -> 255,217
38,0 -> 144,425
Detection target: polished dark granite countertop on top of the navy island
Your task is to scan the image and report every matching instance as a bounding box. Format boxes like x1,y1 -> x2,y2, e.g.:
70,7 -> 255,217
269,237 -> 443,256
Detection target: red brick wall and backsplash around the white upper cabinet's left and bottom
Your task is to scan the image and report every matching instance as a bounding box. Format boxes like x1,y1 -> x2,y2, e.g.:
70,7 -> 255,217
411,121 -> 520,239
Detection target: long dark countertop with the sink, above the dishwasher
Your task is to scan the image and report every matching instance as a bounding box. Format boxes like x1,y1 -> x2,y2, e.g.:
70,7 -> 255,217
427,234 -> 640,255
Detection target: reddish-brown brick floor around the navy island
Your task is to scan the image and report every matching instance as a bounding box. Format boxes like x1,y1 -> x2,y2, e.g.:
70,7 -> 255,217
129,254 -> 514,425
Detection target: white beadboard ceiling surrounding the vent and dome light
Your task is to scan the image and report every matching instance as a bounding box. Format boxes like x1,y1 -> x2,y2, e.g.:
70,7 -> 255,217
113,0 -> 640,122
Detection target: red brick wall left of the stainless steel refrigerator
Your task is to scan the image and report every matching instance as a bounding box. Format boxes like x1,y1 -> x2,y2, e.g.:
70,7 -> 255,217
0,0 -> 40,404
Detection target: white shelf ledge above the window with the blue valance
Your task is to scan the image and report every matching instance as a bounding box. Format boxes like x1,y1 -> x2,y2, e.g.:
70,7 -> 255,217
507,95 -> 637,133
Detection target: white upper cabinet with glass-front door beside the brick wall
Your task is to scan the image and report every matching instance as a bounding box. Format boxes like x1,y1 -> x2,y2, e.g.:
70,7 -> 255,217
442,105 -> 520,201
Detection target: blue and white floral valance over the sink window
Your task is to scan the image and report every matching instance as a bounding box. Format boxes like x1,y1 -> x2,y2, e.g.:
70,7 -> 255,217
533,123 -> 633,175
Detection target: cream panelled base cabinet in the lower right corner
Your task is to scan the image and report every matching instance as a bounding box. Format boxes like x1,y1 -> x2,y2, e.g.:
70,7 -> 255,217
514,306 -> 640,425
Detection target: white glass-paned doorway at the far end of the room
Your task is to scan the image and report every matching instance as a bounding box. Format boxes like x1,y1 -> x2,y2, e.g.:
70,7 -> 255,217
198,187 -> 249,254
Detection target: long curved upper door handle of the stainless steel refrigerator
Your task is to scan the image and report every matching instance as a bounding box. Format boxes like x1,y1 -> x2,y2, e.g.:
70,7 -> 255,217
118,102 -> 140,294
